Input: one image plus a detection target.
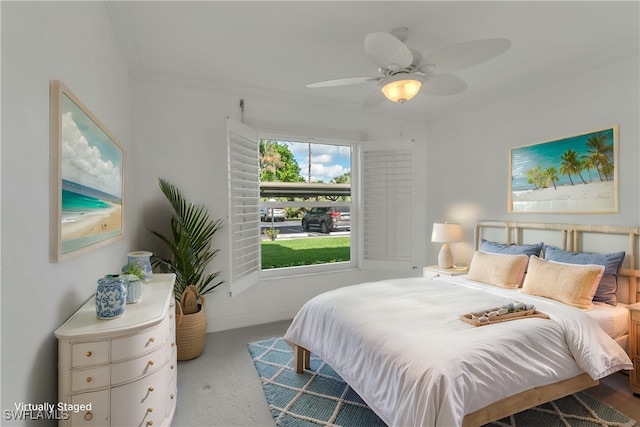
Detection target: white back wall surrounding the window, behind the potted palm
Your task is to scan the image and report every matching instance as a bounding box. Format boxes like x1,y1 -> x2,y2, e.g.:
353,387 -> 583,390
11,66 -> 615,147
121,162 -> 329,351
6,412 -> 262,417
134,79 -> 427,331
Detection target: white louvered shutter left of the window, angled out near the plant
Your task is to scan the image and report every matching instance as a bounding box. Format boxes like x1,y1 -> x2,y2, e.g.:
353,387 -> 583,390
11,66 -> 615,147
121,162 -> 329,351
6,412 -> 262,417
227,118 -> 261,296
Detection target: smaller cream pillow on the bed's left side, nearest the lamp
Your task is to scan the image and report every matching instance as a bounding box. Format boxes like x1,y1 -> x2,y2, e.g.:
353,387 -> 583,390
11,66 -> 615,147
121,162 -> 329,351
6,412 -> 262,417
467,251 -> 529,289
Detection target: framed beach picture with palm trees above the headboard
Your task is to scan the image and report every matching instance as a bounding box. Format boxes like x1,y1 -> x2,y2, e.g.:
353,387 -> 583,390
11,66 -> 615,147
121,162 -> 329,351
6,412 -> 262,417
509,126 -> 618,214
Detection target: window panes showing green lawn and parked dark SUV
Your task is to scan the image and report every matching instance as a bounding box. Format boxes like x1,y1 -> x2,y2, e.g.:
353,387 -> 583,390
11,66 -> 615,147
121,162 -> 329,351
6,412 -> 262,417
259,138 -> 355,275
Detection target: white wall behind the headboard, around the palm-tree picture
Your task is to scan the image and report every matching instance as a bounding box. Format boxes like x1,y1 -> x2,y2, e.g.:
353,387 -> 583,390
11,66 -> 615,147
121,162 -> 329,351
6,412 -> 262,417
426,54 -> 640,261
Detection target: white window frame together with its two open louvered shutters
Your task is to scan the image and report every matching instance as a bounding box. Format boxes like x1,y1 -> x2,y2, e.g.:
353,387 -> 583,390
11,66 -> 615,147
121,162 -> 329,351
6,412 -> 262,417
227,117 -> 418,297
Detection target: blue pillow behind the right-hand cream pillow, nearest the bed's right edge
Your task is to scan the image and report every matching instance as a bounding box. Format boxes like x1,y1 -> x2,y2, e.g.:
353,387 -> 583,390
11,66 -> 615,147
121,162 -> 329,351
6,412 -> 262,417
544,246 -> 625,306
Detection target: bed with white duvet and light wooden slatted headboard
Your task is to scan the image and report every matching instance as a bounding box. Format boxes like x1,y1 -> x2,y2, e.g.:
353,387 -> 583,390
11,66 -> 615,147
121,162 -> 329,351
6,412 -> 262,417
285,221 -> 640,426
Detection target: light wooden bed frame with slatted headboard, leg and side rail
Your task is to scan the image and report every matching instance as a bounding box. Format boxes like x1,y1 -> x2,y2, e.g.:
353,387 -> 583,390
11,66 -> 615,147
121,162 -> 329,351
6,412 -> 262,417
294,221 -> 640,427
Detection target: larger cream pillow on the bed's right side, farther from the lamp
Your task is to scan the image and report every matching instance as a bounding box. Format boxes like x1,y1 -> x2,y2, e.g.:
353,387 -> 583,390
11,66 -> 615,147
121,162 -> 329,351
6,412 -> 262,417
522,255 -> 604,309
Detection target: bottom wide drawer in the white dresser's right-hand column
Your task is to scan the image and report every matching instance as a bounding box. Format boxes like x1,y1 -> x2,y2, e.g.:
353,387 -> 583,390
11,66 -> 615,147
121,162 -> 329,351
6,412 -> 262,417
111,369 -> 167,427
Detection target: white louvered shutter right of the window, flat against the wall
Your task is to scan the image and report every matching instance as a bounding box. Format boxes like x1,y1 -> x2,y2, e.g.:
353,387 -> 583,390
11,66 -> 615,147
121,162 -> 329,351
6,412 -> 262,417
361,147 -> 413,269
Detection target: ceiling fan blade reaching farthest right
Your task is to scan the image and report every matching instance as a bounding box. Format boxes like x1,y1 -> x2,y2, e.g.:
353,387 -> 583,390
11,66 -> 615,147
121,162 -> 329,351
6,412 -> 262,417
422,39 -> 511,74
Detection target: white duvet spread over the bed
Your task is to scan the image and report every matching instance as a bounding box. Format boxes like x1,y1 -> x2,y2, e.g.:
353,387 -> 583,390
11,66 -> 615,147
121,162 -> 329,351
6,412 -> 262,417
285,278 -> 632,426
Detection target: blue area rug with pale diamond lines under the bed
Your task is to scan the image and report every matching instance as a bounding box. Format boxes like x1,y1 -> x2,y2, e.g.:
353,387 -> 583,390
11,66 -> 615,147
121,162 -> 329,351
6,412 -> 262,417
248,338 -> 635,427
